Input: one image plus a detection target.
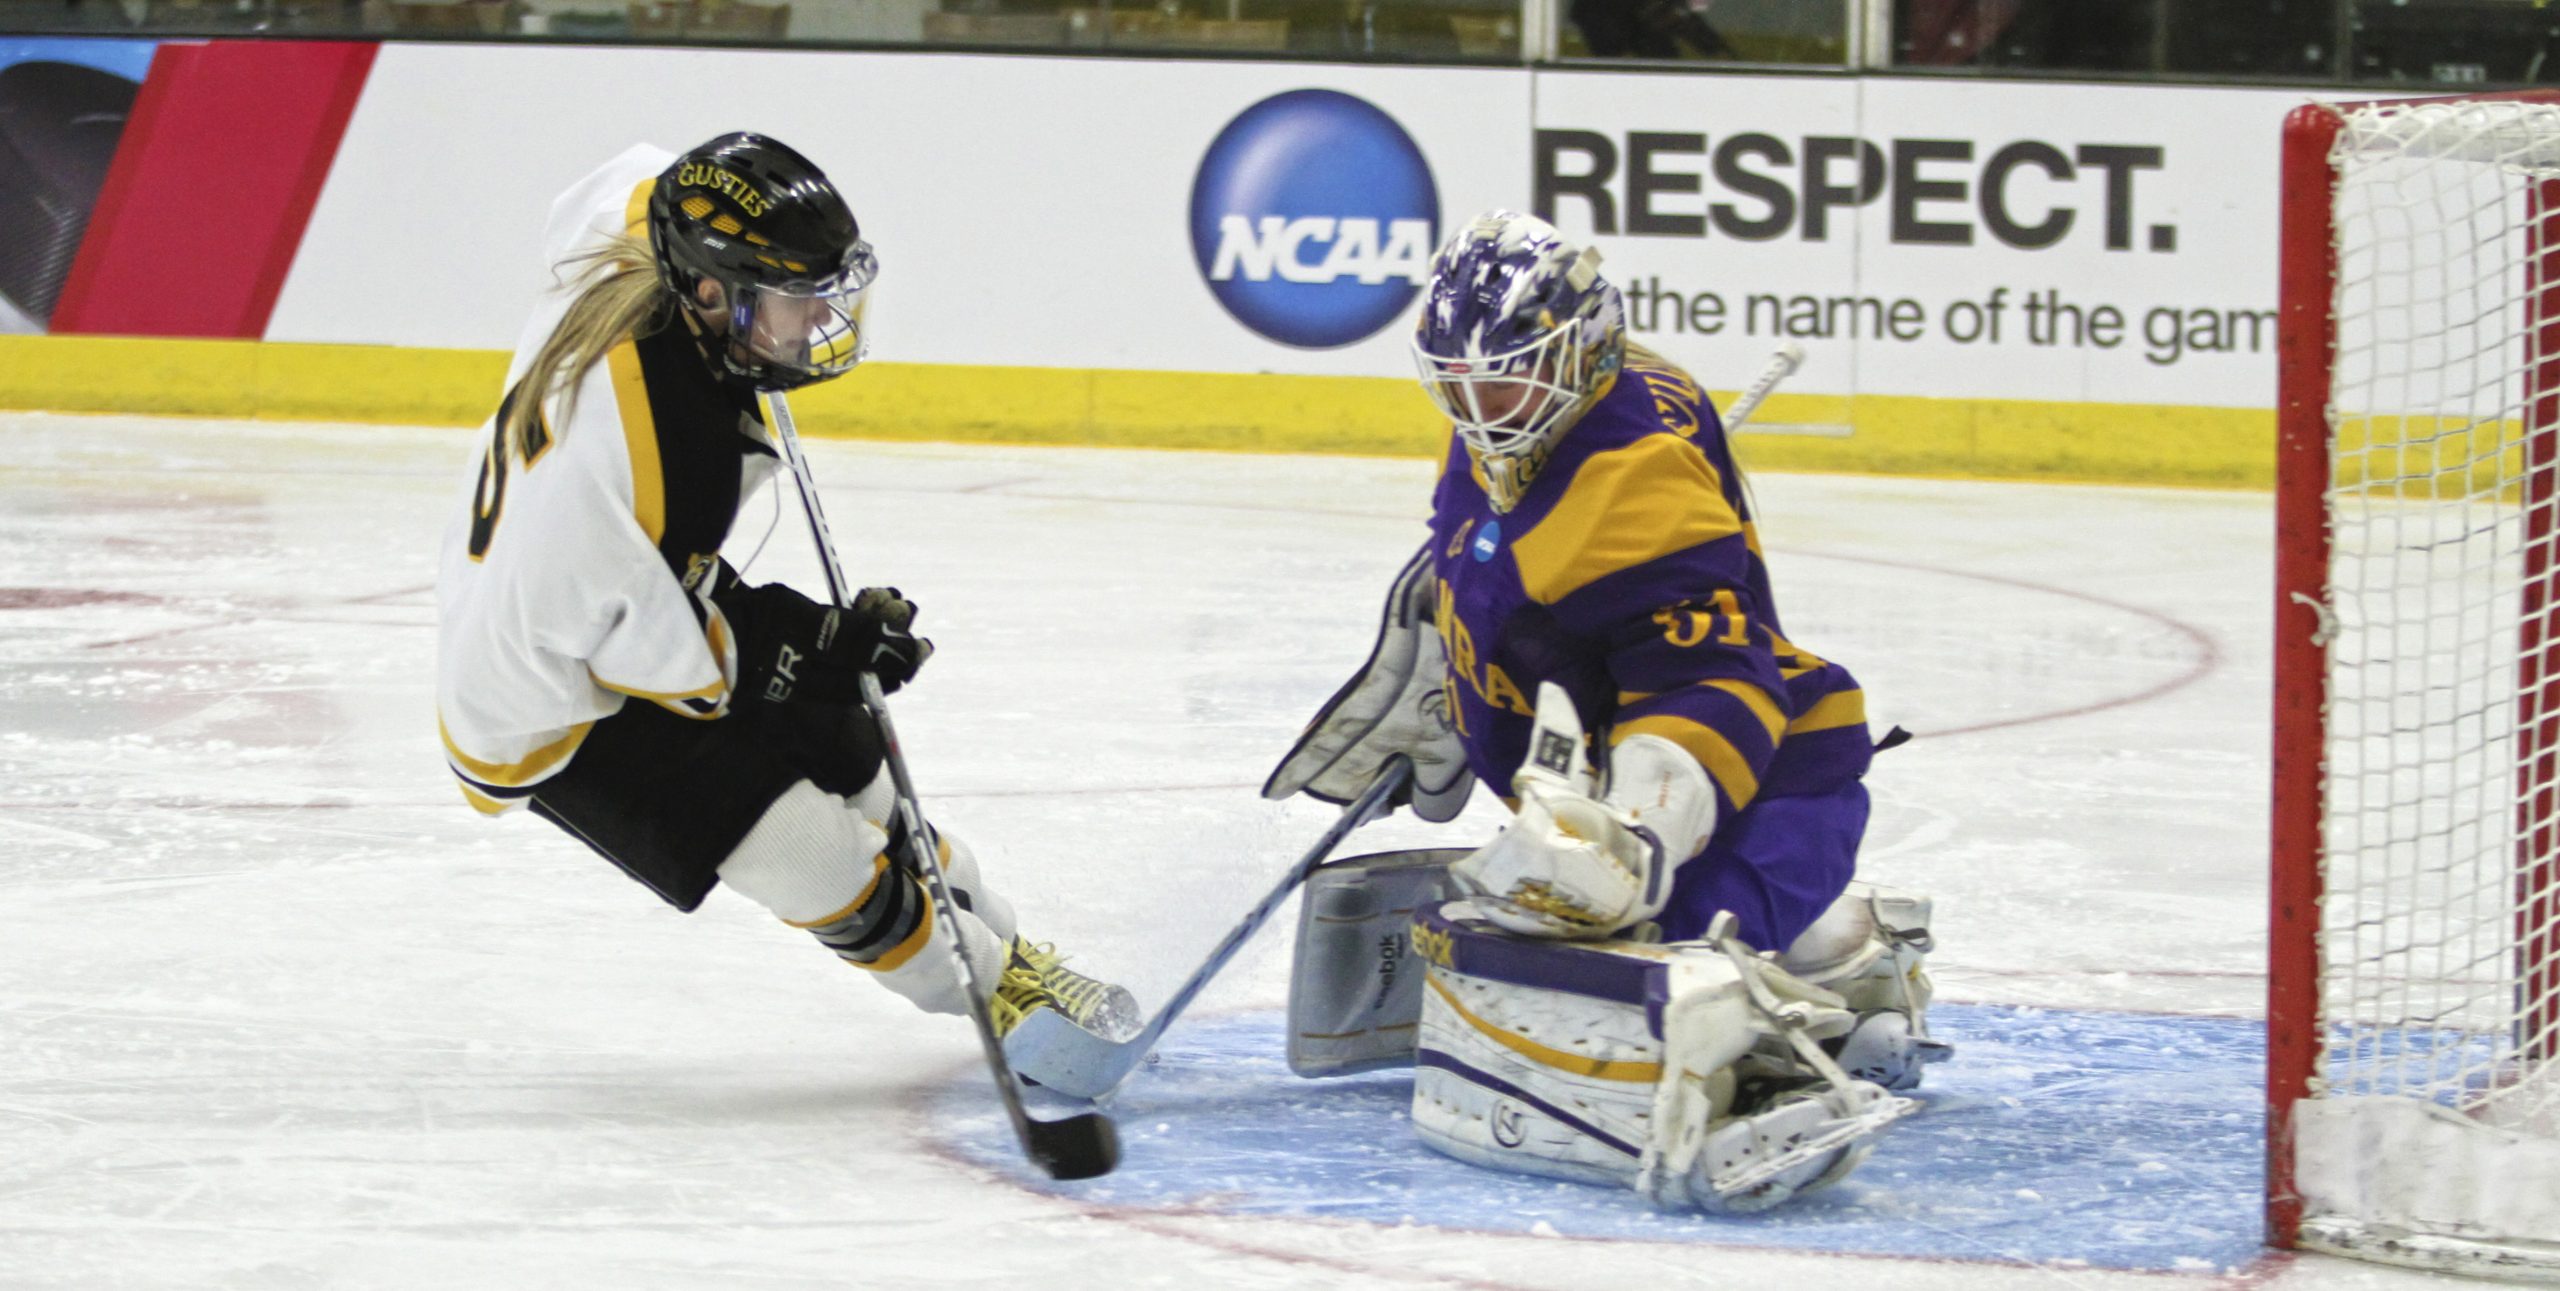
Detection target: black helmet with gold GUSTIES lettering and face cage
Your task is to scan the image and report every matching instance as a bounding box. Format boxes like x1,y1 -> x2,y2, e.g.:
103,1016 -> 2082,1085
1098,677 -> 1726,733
648,133 -> 881,392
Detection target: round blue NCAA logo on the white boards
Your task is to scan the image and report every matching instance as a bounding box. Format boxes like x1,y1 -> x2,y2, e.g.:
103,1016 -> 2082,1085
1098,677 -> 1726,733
1190,90 -> 1439,348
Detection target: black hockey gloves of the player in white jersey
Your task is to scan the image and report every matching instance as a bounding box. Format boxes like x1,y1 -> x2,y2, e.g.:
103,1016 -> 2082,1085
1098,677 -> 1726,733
712,566 -> 934,704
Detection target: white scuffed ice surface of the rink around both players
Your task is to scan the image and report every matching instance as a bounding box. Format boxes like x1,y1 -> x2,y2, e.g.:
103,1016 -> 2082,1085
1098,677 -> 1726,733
0,415 -> 2478,1291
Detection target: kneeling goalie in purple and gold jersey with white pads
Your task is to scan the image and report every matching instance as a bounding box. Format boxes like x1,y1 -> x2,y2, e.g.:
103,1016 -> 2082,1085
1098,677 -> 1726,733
1267,210 -> 1946,1212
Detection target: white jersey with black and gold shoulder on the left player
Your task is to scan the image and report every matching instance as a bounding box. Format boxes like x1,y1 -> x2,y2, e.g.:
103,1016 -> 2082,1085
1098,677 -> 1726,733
435,146 -> 773,815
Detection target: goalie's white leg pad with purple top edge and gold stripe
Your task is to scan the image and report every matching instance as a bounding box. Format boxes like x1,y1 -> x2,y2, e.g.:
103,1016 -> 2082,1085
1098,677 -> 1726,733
1413,902 -> 1917,1212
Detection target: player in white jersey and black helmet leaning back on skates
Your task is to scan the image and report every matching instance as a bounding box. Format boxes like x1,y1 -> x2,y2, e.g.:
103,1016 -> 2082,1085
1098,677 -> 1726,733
435,133 -> 1137,1060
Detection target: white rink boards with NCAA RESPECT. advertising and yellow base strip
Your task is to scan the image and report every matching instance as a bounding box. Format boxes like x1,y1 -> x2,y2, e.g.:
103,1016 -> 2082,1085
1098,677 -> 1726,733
0,38 -> 2307,487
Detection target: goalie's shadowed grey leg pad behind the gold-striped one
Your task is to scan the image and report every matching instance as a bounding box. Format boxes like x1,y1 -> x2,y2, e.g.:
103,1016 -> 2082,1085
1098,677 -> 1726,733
1288,848 -> 1467,1076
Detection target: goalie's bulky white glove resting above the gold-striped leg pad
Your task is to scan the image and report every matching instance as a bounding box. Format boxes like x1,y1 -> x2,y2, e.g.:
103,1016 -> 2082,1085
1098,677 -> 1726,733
1449,681 -> 1715,938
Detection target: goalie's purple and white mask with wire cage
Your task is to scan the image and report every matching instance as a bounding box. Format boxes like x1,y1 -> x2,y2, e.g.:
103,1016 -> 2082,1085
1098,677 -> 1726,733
1413,210 -> 1626,474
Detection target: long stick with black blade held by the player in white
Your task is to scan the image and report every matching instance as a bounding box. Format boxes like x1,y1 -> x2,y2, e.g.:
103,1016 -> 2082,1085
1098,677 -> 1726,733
765,394 -> 1119,1178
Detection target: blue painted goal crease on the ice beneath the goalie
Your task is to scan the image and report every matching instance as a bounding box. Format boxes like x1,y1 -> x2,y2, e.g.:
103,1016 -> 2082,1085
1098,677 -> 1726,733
934,1004 -> 2266,1273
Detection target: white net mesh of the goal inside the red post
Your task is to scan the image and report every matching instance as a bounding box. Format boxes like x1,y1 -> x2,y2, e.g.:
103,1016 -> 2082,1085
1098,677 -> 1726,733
2304,100 -> 2560,1265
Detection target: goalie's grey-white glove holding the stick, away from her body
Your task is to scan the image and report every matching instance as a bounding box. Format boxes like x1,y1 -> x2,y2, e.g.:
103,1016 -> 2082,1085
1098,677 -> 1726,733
1262,543 -> 1475,822
